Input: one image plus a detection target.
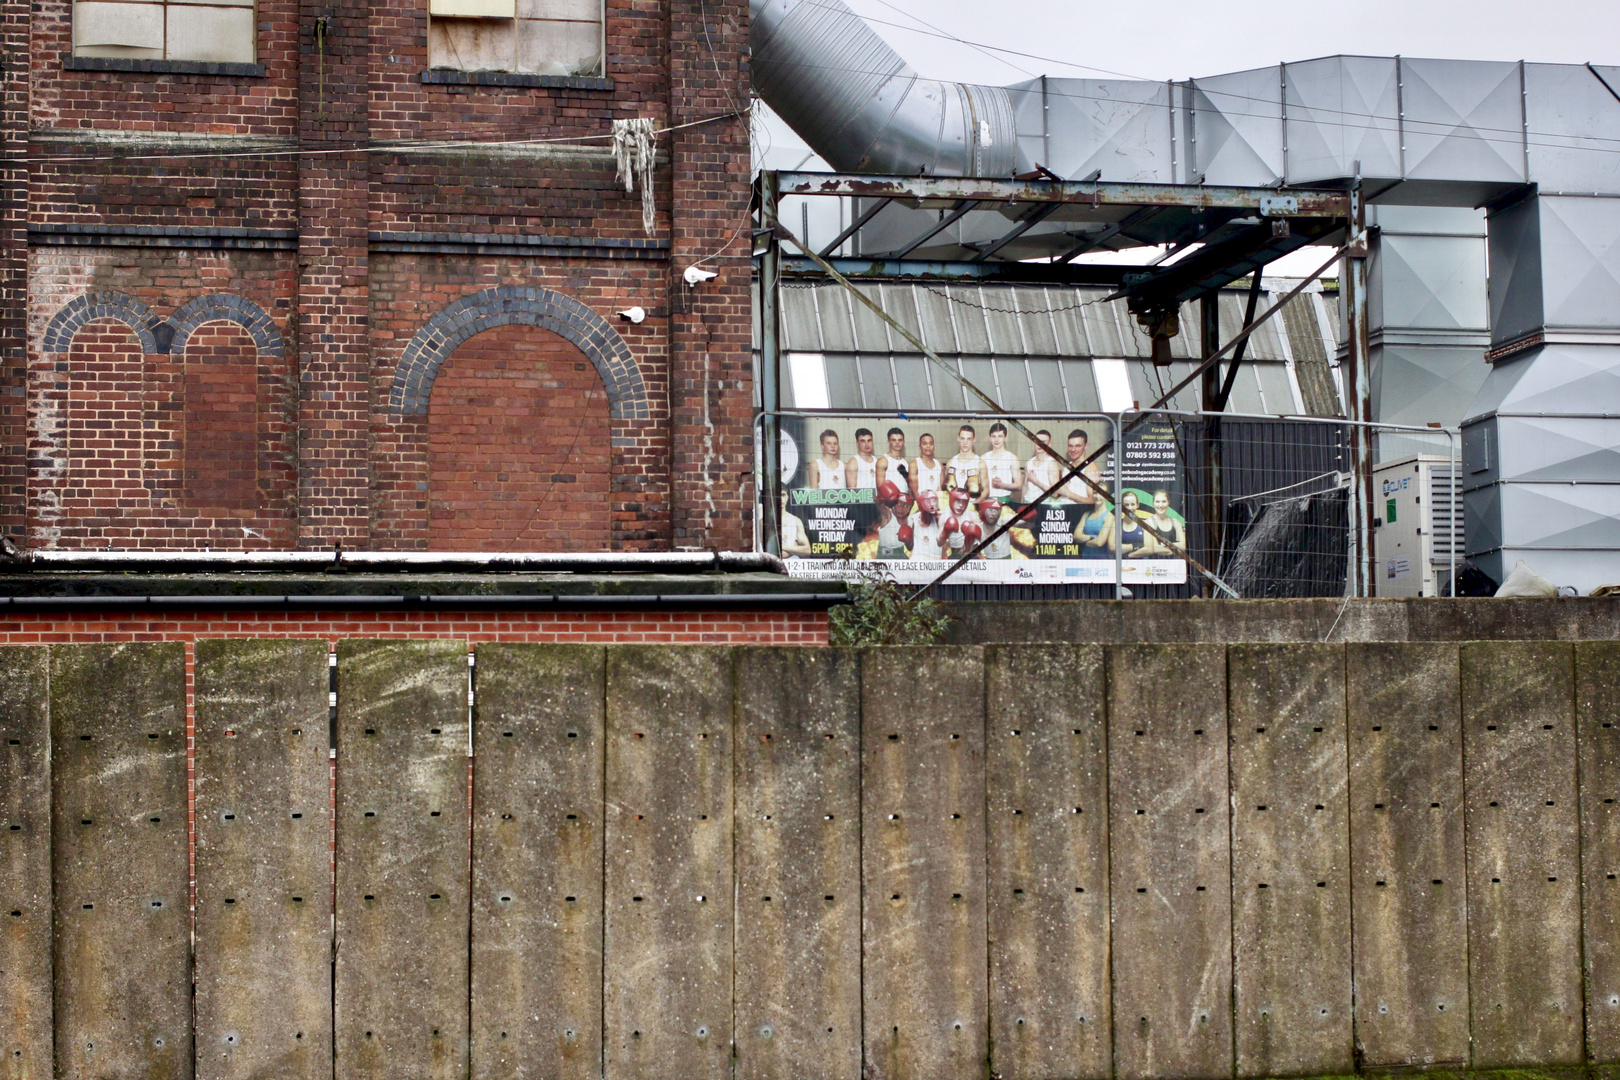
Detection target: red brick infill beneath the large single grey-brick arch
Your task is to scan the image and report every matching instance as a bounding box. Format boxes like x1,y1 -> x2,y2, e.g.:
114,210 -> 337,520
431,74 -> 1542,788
426,324 -> 612,551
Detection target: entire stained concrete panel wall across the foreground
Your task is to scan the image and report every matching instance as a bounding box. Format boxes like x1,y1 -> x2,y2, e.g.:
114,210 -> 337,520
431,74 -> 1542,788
0,641 -> 1620,1080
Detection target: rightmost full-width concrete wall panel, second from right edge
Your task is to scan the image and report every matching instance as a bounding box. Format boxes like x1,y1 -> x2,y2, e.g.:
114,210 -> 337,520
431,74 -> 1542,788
1461,641 -> 1583,1069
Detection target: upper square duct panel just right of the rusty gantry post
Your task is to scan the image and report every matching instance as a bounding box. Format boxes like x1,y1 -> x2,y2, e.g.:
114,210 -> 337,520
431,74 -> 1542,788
1377,235 -> 1490,332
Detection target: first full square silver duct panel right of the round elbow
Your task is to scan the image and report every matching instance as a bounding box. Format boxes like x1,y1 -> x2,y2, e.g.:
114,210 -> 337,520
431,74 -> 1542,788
1047,79 -> 1176,183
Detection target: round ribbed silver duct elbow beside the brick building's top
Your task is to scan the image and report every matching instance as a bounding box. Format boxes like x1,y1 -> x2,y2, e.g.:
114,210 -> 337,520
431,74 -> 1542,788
748,0 -> 1017,176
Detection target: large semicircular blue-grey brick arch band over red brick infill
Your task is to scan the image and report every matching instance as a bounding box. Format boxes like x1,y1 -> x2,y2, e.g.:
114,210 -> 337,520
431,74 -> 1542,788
389,285 -> 651,419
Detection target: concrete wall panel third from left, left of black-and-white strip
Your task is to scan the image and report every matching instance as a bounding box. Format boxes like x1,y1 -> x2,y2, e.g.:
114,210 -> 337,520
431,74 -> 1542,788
194,640 -> 332,1080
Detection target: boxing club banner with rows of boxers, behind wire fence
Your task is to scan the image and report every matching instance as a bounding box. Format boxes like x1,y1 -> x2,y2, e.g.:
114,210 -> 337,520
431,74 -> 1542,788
781,416 -> 1187,585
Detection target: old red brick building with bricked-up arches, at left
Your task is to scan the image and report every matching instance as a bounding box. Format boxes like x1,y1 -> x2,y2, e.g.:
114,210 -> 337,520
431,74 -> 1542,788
0,0 -> 753,551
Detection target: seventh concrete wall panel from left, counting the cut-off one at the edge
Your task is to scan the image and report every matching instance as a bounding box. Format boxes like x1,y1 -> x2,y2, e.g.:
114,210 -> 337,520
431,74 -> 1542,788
734,649 -> 860,1080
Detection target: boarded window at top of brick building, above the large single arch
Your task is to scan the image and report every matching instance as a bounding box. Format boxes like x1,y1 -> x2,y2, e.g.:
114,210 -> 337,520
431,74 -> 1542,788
428,0 -> 604,76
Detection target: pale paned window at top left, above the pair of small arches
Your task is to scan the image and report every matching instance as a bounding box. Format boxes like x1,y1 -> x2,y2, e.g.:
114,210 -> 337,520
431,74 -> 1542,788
73,0 -> 258,63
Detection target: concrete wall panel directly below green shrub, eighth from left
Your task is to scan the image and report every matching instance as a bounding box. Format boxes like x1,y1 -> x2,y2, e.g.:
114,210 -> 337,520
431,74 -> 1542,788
860,648 -> 988,1080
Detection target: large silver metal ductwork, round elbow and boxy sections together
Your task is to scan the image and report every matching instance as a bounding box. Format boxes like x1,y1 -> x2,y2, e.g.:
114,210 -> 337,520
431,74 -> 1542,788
750,0 -> 1620,591
